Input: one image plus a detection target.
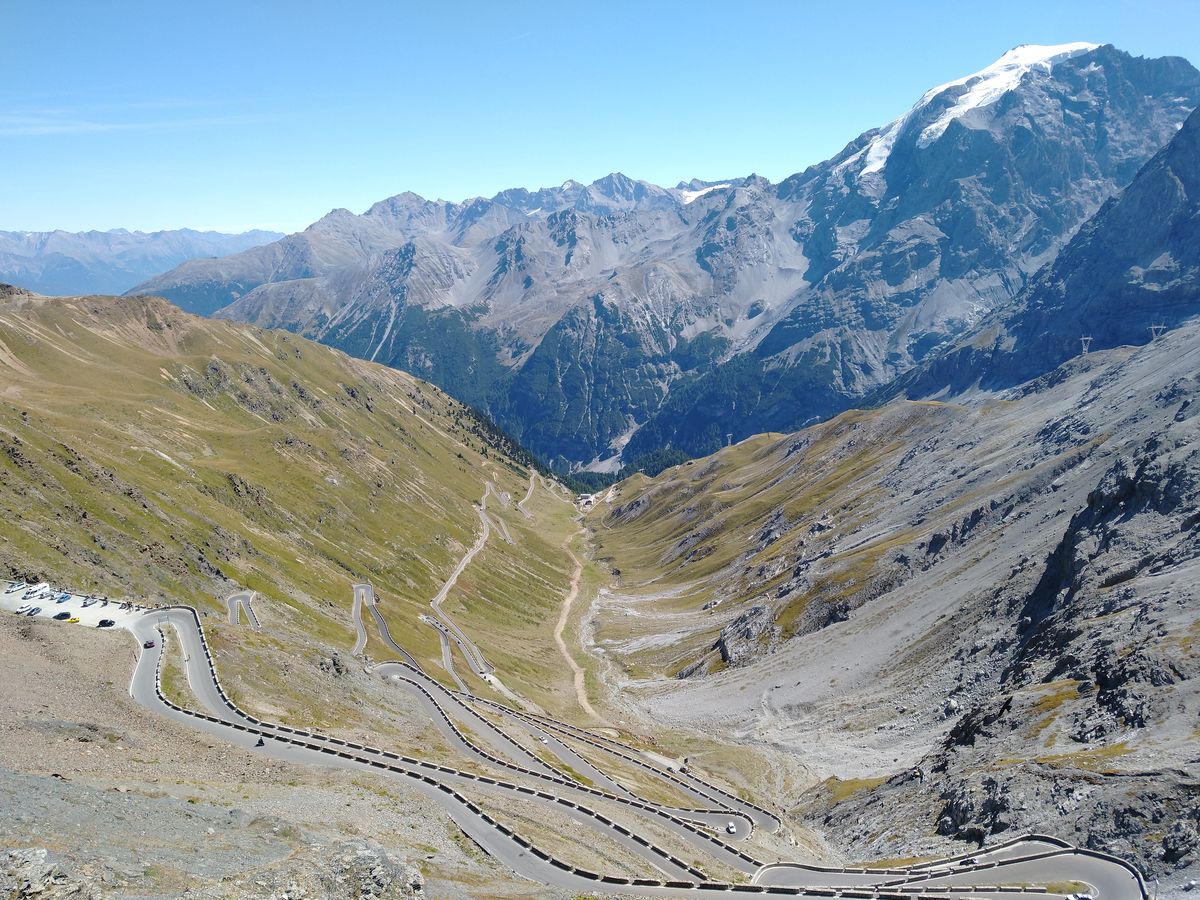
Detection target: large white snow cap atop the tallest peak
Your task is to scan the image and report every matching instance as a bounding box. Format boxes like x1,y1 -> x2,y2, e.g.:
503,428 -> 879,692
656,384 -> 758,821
859,41 -> 1099,181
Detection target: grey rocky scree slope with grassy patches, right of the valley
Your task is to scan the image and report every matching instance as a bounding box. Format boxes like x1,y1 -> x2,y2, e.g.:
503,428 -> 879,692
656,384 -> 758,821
595,322 -> 1200,896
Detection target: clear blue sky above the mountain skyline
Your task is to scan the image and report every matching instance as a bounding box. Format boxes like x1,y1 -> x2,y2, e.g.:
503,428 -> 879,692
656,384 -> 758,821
0,0 -> 1200,230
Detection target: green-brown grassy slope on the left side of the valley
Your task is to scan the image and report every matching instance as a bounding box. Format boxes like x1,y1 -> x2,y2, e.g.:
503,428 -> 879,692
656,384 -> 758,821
0,290 -> 583,715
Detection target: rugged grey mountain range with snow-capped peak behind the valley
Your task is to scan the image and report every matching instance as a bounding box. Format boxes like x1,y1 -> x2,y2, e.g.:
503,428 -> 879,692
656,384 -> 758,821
134,43 -> 1200,470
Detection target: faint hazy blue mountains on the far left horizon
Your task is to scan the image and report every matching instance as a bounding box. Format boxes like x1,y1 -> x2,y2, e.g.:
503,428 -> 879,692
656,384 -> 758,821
0,228 -> 283,296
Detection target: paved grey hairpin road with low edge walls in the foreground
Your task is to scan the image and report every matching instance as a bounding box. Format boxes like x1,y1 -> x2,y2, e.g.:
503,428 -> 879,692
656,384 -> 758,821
7,586 -> 1146,900
